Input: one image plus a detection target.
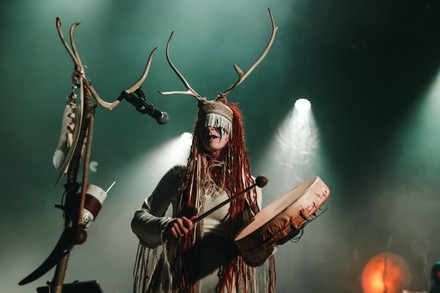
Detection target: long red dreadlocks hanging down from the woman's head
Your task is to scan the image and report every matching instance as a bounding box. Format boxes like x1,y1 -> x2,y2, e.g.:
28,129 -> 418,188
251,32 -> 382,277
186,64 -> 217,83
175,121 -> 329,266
174,104 -> 257,292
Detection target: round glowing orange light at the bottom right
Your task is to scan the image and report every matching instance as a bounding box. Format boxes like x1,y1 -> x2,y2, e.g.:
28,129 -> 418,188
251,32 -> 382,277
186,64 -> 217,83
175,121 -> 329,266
362,252 -> 410,293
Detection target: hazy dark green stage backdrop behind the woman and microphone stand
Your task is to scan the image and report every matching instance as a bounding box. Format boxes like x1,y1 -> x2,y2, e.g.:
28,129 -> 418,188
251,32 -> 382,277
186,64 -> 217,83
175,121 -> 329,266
0,0 -> 440,293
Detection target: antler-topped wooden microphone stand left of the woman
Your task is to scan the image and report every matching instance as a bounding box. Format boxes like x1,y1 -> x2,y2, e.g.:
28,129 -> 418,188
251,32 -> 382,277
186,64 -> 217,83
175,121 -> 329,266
19,18 -> 160,293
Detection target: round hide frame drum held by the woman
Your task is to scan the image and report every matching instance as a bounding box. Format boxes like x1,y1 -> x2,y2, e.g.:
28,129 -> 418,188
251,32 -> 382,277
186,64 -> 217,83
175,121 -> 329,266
234,176 -> 330,267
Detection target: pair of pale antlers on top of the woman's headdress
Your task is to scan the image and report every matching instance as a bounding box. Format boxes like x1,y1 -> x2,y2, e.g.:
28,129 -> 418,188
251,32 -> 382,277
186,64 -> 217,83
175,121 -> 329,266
159,9 -> 278,103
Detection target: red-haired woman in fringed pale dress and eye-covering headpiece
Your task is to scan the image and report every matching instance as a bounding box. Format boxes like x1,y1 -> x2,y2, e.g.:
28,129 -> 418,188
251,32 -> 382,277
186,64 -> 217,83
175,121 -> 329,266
131,99 -> 275,292
